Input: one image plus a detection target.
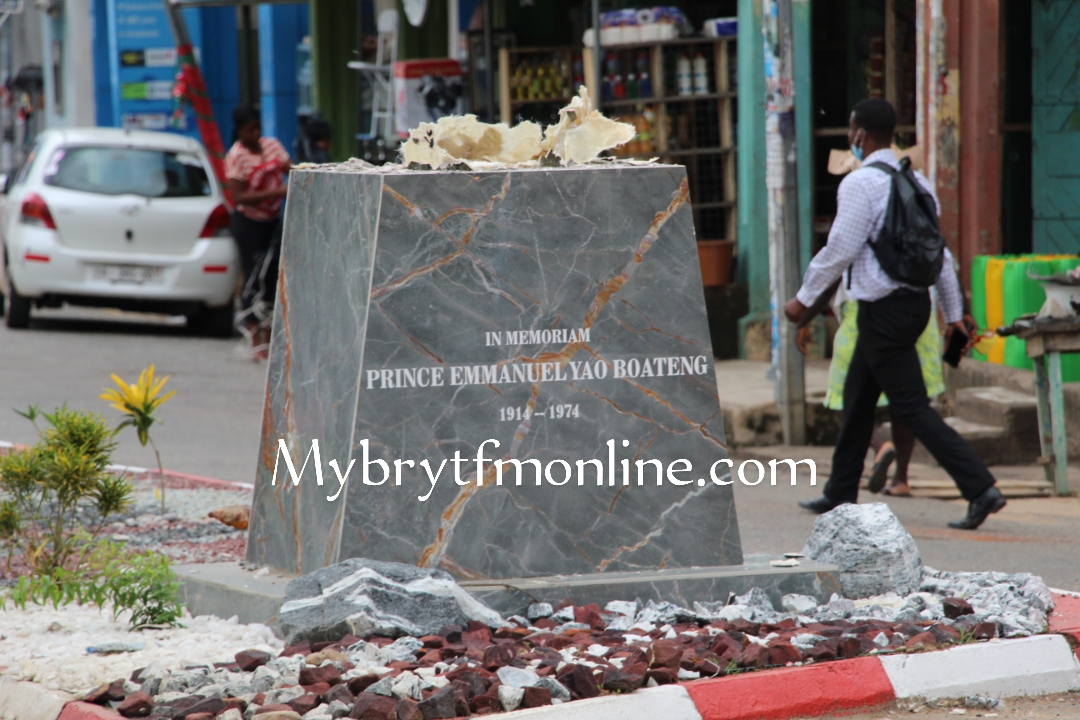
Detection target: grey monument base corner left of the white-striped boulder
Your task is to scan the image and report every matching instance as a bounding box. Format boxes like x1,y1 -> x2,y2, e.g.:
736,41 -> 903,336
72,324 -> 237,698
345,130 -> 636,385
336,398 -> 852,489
176,562 -> 293,633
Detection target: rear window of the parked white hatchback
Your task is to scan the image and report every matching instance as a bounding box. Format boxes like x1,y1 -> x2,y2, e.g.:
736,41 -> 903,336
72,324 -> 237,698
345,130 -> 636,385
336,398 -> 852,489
44,146 -> 211,198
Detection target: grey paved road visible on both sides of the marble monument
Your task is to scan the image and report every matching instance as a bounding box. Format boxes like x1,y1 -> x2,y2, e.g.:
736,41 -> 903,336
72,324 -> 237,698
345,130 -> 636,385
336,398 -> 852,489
0,310 -> 1080,589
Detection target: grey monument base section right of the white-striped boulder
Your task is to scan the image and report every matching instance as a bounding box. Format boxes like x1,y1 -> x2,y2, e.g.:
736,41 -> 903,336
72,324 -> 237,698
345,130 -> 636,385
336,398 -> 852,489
460,555 -> 840,614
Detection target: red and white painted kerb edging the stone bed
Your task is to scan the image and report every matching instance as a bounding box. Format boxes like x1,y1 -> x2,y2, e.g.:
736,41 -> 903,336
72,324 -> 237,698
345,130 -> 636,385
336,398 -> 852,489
39,592 -> 1080,720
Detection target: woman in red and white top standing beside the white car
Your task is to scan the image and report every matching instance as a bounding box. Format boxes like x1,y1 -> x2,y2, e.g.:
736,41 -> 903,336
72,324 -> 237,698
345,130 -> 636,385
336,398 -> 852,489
225,105 -> 292,362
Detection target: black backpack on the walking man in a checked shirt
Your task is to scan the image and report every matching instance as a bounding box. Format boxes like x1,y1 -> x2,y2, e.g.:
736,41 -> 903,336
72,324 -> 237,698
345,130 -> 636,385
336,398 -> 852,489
866,158 -> 945,287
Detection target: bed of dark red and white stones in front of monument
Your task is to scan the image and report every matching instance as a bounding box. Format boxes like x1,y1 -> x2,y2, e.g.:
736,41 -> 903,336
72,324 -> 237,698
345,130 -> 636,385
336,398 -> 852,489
42,569 -> 1051,720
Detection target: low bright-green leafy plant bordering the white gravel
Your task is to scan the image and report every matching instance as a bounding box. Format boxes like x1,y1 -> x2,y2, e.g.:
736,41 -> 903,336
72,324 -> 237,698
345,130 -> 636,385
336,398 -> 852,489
0,541 -> 183,628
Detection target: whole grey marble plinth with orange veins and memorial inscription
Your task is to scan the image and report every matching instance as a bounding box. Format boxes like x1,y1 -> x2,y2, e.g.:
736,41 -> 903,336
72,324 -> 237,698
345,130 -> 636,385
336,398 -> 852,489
248,164 -> 742,580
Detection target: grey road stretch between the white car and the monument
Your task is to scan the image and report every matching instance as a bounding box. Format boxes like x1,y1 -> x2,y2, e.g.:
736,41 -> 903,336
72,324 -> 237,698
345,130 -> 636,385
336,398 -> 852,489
0,309 -> 266,483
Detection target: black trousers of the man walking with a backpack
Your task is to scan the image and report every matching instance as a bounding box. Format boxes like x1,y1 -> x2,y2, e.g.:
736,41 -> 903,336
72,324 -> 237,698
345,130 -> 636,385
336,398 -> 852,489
825,290 -> 995,502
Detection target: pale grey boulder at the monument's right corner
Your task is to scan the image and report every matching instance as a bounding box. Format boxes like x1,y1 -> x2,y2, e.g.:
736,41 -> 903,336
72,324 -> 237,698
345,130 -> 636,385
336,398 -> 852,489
802,503 -> 922,599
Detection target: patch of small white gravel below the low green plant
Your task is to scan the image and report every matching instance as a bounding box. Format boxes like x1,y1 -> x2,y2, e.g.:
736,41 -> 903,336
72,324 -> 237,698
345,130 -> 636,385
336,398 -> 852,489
0,601 -> 284,693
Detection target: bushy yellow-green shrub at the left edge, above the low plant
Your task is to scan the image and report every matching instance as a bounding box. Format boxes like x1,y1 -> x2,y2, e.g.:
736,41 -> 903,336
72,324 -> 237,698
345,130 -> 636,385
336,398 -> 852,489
0,406 -> 132,575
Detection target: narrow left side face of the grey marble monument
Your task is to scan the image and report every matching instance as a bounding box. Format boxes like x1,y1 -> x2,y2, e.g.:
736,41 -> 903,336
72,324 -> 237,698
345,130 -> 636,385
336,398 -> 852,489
247,173 -> 381,571
